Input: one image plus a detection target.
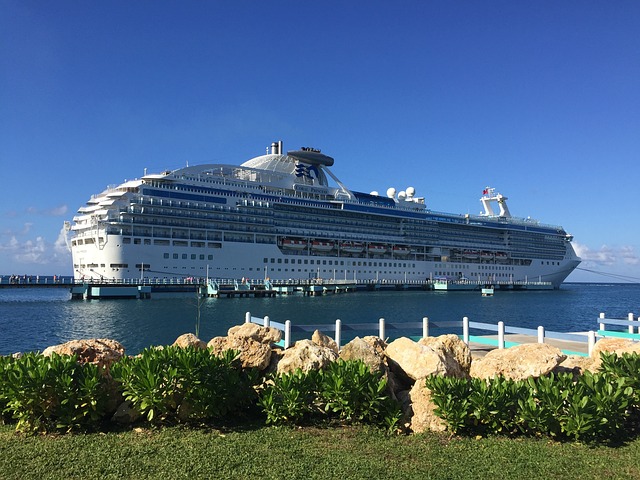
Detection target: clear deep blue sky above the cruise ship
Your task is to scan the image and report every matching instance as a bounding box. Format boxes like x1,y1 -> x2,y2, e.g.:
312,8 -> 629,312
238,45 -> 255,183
0,0 -> 640,281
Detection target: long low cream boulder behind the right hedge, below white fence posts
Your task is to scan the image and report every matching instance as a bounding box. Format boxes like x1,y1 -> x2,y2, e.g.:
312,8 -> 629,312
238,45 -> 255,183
470,343 -> 567,380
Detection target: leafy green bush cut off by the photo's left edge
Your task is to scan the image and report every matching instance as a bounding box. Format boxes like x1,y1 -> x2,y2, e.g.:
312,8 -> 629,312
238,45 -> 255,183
0,353 -> 107,433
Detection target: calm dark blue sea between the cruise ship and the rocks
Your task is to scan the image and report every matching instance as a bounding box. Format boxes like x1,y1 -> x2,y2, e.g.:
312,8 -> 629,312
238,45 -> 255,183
0,283 -> 640,355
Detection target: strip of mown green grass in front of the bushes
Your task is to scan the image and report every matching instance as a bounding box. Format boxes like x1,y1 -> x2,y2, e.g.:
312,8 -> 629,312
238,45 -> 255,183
0,425 -> 640,480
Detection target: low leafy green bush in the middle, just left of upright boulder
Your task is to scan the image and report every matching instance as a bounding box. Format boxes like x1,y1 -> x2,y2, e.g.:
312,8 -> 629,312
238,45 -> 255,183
259,360 -> 401,431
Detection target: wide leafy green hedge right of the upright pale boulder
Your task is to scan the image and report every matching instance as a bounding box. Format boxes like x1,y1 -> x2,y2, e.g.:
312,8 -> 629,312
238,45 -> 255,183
426,350 -> 640,442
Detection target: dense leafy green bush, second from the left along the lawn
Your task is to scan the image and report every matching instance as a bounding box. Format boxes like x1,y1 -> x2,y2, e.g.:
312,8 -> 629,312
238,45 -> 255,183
111,347 -> 255,423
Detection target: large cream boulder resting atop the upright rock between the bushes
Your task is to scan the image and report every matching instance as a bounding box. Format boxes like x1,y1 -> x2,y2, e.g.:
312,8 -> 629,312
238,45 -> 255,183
385,337 -> 466,381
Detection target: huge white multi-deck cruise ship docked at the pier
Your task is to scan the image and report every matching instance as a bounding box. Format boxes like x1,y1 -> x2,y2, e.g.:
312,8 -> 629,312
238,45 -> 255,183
66,142 -> 580,288
